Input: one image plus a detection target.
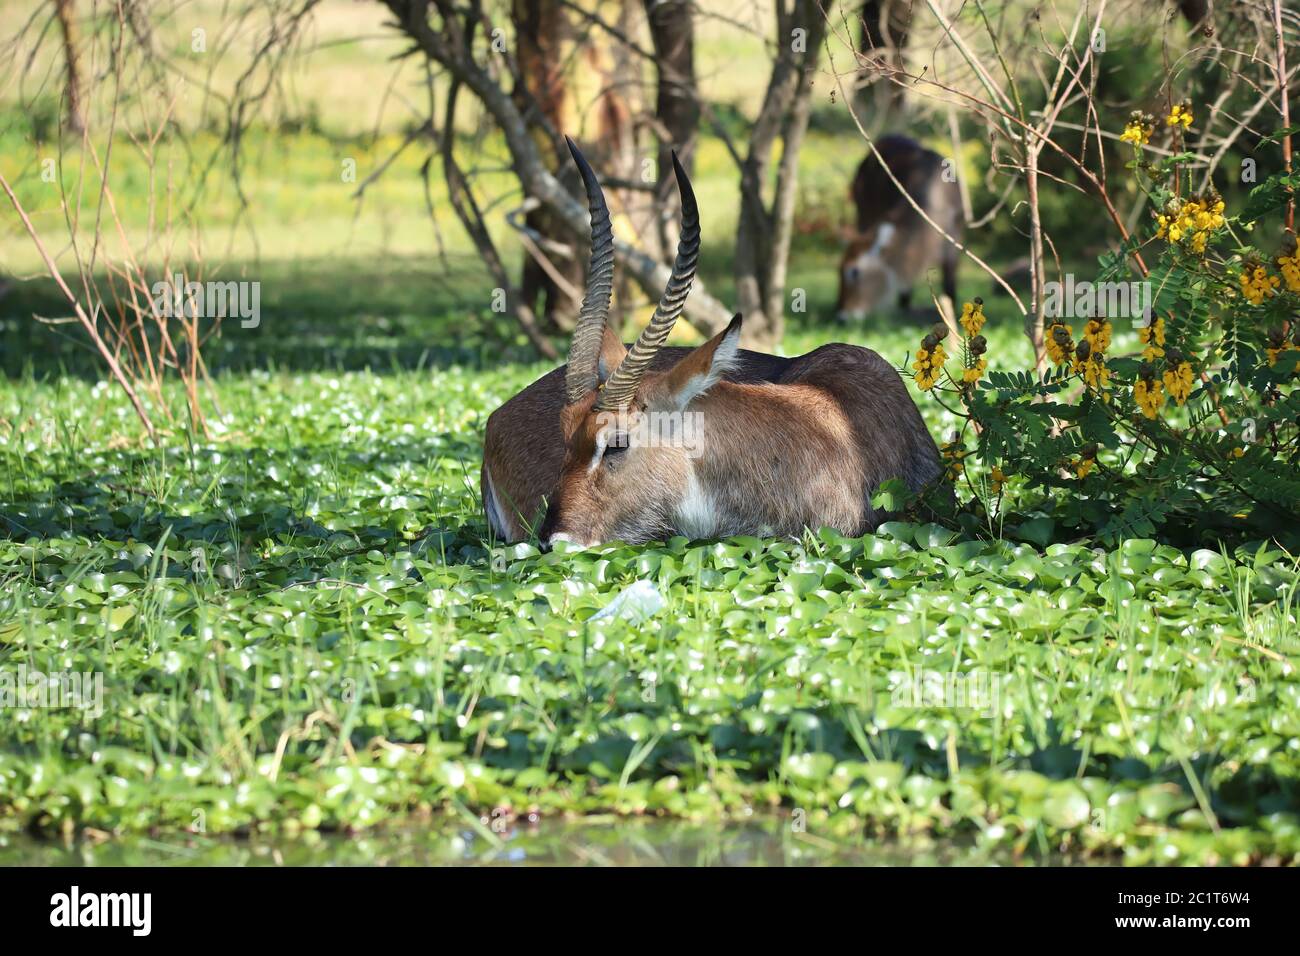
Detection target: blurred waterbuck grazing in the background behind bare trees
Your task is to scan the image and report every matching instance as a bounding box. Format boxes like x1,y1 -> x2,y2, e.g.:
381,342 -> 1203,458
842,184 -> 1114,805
836,135 -> 963,321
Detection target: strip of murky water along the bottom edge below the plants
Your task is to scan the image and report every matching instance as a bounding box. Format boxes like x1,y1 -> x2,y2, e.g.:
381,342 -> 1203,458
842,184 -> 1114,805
0,818 -> 1097,866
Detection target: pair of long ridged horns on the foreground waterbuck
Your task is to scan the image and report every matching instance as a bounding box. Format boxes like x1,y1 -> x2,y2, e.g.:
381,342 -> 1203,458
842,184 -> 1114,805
564,137 -> 699,411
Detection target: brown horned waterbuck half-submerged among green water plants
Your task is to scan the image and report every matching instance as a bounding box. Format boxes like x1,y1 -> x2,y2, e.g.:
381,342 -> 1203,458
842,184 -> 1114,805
482,142 -> 940,545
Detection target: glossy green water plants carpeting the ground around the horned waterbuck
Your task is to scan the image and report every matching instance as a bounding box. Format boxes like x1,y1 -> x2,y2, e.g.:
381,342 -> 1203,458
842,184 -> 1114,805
0,299 -> 1300,862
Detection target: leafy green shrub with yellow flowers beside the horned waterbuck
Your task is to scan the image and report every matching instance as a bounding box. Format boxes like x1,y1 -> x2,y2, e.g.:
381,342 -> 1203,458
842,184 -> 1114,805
913,109 -> 1300,544
